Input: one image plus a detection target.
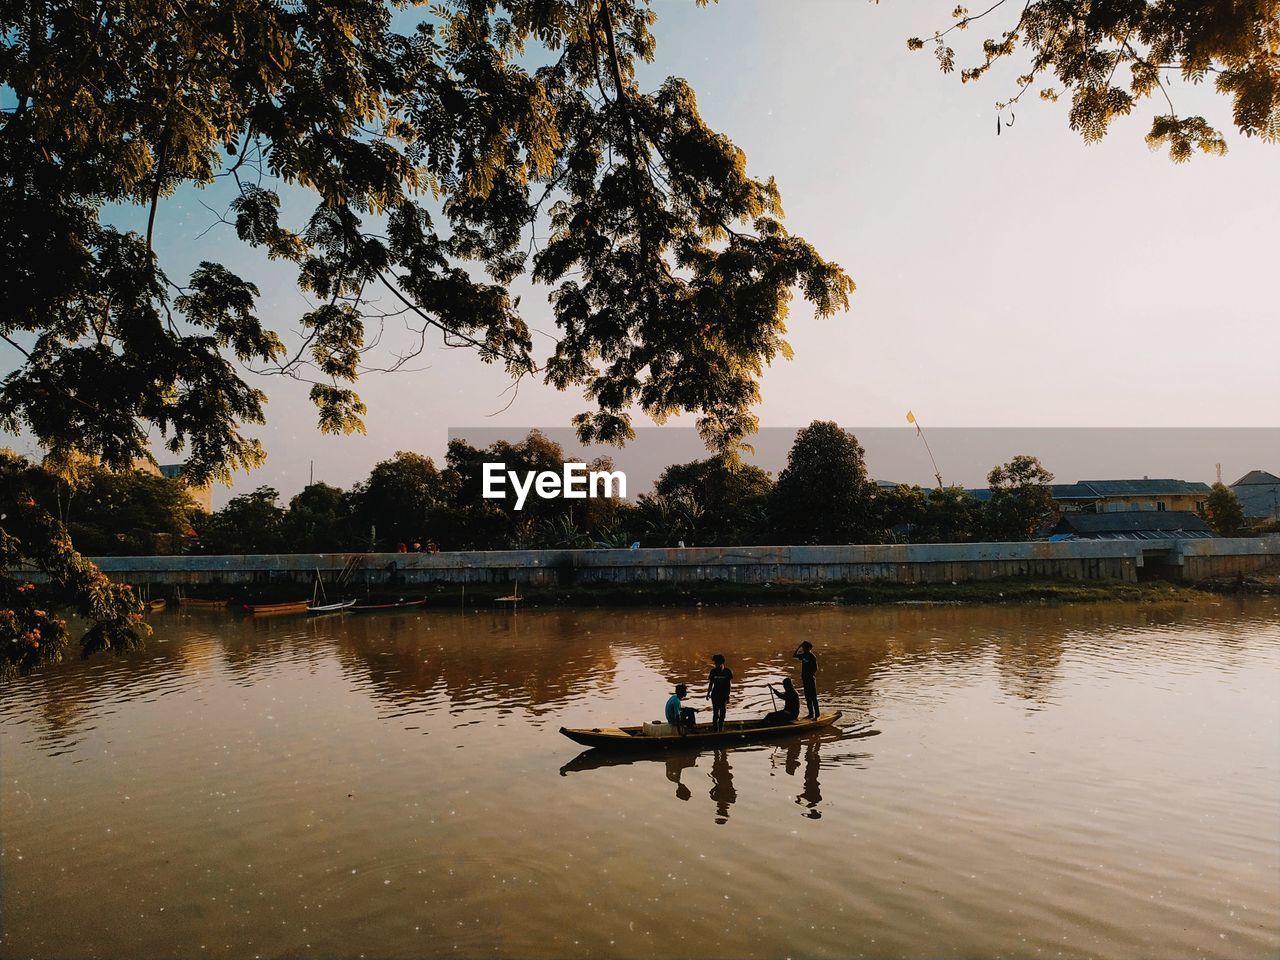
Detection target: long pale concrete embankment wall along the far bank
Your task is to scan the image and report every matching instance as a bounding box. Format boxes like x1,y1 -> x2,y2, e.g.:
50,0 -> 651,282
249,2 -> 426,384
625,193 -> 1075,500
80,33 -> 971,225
74,535 -> 1280,585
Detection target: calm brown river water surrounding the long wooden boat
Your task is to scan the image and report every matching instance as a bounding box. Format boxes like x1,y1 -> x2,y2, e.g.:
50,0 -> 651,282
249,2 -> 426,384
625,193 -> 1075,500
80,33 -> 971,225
0,598 -> 1280,959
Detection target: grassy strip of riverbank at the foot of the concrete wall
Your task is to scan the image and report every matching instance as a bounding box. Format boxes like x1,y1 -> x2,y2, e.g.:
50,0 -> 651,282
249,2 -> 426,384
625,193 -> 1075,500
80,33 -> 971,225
150,577 -> 1224,609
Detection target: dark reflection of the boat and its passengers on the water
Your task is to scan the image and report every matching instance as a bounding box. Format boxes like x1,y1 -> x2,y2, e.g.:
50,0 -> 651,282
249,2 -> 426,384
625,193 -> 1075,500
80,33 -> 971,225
559,722 -> 879,823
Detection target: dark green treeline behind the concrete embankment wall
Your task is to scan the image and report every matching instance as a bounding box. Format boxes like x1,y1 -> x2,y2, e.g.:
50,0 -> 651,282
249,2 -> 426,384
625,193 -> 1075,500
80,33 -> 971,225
0,421 -> 1259,556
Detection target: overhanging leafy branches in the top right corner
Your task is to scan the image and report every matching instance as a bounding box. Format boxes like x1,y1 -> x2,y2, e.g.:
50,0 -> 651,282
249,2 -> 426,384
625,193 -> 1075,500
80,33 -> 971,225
908,0 -> 1280,163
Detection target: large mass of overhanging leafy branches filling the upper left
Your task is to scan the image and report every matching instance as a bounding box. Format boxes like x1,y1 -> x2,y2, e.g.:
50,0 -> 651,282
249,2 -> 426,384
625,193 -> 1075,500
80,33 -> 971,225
0,0 -> 852,483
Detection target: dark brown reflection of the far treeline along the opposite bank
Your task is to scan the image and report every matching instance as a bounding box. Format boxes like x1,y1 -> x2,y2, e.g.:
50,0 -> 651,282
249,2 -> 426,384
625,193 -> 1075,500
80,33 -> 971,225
12,598 -> 1275,751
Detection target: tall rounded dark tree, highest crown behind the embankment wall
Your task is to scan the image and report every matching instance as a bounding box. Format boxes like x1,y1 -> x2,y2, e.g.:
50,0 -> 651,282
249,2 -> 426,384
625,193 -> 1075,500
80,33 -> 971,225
769,420 -> 878,544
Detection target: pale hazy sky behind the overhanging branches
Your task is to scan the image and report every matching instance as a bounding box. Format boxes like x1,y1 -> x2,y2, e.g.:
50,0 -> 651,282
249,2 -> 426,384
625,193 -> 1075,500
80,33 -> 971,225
0,0 -> 1280,503
